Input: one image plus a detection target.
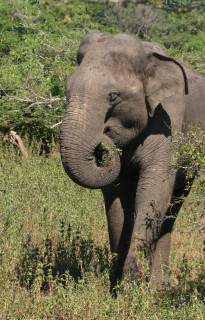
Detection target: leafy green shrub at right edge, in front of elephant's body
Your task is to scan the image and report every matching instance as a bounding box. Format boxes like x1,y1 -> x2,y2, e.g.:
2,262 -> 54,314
174,126 -> 205,234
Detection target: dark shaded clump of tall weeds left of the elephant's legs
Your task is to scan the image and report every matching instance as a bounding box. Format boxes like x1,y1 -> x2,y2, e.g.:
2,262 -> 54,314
16,222 -> 111,290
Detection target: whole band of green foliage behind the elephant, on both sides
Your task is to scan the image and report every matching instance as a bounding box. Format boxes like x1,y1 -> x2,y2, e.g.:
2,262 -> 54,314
0,0 -> 205,150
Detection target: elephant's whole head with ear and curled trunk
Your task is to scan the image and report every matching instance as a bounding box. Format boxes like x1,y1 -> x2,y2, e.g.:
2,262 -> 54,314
60,32 -> 187,188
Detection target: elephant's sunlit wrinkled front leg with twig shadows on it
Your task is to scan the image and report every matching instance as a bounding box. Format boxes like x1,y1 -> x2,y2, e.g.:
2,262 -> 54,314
123,167 -> 175,281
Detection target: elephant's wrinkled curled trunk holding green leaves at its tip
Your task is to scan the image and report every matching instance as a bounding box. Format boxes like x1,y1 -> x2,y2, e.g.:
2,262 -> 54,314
60,101 -> 120,189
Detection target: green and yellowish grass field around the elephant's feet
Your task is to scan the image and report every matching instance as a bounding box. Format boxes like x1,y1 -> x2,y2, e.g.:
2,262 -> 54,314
0,148 -> 205,320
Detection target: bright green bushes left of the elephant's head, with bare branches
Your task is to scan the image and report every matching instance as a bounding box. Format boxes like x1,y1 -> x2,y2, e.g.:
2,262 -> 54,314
0,0 -> 117,151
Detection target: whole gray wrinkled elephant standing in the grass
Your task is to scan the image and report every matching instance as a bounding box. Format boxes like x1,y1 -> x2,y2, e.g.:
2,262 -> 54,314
61,33 -> 205,286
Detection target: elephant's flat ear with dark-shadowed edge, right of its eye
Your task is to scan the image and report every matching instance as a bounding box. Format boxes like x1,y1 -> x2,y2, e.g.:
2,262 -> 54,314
144,52 -> 188,116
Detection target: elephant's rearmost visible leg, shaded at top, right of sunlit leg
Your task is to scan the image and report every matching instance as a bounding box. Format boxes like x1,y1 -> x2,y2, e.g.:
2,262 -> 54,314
150,182 -> 192,285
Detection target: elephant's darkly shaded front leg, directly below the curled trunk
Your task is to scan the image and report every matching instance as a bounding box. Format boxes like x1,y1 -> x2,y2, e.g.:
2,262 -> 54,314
102,182 -> 134,289
